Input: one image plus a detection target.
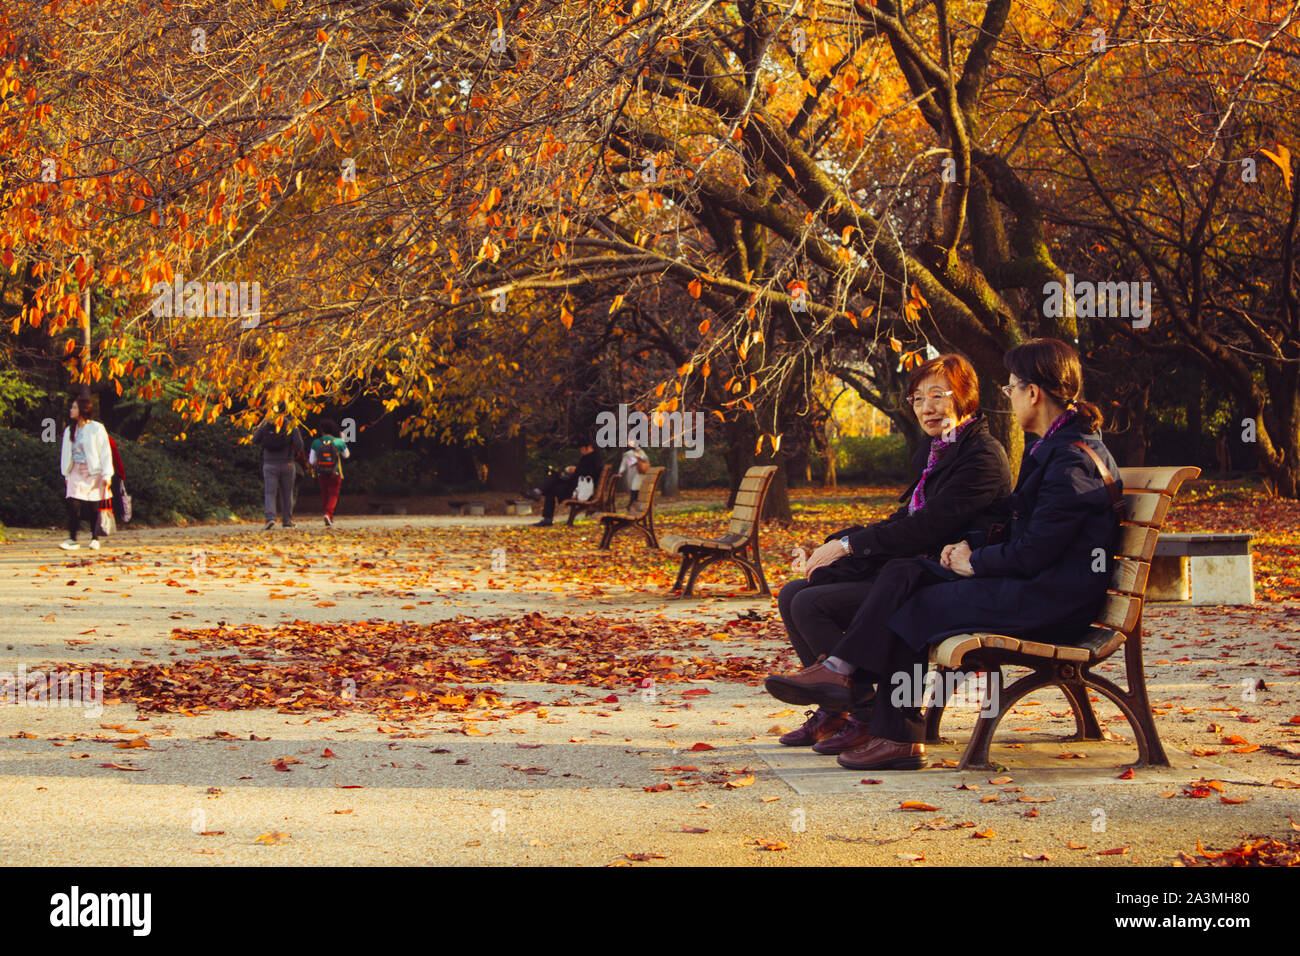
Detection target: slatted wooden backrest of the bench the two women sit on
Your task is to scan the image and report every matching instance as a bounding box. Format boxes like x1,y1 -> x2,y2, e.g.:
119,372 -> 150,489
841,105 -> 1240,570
1097,466 -> 1201,657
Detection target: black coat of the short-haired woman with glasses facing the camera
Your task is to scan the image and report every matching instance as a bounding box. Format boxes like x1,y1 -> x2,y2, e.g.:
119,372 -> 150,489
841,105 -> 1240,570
809,415 -> 1011,584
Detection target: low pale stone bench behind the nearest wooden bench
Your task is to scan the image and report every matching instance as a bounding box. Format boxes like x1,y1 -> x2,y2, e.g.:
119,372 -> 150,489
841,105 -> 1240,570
1147,533 -> 1255,605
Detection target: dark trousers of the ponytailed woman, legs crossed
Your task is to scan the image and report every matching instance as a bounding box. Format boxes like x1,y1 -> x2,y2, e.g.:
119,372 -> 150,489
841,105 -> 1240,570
831,558 -> 946,744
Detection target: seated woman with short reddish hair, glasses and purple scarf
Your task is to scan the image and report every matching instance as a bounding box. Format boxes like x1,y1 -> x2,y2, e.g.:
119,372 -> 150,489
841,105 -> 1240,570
777,354 -> 1011,754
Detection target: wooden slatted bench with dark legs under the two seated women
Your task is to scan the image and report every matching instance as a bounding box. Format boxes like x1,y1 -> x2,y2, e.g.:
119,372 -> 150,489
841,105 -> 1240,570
926,467 -> 1201,770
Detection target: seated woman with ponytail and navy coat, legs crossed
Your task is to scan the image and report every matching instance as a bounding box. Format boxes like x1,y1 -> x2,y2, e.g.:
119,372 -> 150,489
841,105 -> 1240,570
768,338 -> 1122,770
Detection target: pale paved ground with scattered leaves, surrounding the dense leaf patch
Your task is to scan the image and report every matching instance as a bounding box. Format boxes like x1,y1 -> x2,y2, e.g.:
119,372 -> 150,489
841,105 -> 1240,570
0,516 -> 1300,866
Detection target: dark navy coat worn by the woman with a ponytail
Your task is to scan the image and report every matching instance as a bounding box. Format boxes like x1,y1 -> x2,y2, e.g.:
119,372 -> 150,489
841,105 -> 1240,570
889,420 -> 1122,650
